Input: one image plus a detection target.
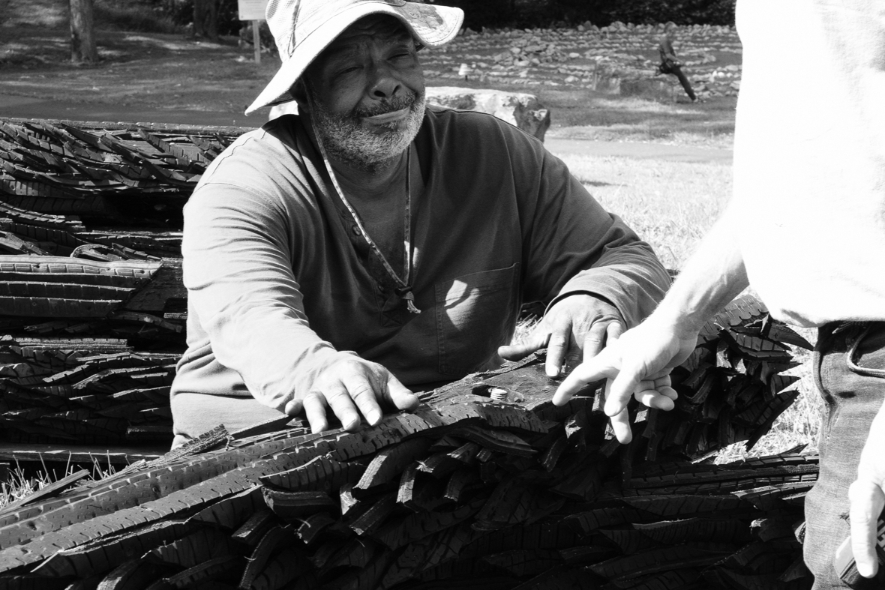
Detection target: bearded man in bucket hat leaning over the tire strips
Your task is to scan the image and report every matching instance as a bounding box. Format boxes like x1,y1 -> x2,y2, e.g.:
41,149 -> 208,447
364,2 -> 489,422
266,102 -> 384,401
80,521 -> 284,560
172,0 -> 669,445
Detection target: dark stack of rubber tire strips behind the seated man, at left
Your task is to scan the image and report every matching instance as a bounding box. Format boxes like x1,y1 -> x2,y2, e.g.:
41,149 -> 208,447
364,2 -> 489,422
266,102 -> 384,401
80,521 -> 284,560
0,120 -> 244,445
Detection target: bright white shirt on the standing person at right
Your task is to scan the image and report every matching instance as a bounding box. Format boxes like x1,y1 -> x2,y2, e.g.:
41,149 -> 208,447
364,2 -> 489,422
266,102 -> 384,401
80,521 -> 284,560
733,0 -> 885,326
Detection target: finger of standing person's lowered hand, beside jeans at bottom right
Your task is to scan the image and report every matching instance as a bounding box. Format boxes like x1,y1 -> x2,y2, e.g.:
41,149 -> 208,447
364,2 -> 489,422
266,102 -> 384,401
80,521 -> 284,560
848,480 -> 885,578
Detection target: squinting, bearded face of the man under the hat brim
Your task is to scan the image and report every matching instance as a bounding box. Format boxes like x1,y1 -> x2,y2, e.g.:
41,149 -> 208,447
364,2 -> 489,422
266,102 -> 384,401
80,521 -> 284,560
303,15 -> 424,170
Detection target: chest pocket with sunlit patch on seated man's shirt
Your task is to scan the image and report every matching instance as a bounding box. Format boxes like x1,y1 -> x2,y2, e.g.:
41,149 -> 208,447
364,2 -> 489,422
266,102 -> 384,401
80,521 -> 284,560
435,263 -> 519,377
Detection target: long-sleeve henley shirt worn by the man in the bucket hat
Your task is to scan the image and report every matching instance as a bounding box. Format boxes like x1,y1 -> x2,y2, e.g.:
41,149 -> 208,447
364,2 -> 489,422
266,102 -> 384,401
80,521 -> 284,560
172,109 -> 669,409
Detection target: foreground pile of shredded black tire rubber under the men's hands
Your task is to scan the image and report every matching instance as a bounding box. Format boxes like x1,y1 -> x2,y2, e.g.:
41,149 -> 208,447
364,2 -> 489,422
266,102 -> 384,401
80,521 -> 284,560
0,300 -> 817,590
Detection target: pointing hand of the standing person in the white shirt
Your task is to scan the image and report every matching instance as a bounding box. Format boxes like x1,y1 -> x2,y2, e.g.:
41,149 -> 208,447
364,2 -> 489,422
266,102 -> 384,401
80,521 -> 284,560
553,316 -> 698,444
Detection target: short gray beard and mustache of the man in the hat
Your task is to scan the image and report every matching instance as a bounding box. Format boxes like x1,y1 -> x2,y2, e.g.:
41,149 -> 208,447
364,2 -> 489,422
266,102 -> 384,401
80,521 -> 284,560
311,94 -> 424,174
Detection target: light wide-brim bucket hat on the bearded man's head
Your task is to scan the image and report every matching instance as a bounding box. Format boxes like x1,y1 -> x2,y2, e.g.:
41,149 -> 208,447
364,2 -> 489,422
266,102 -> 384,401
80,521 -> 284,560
246,0 -> 464,115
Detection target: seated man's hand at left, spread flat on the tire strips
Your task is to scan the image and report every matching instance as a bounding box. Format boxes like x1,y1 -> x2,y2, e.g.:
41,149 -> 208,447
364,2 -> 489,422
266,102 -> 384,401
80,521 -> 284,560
284,354 -> 419,432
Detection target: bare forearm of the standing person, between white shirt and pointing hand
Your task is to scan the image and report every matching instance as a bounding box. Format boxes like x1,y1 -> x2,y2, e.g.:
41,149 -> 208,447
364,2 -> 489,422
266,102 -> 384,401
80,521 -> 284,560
652,209 -> 749,333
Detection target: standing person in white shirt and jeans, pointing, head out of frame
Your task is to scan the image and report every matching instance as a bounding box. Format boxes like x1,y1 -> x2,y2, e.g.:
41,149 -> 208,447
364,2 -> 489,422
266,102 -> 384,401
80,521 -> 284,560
554,0 -> 885,590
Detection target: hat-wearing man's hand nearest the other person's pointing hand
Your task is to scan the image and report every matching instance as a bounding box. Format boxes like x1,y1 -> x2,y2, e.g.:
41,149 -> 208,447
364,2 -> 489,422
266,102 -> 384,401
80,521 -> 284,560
498,295 -> 624,377
